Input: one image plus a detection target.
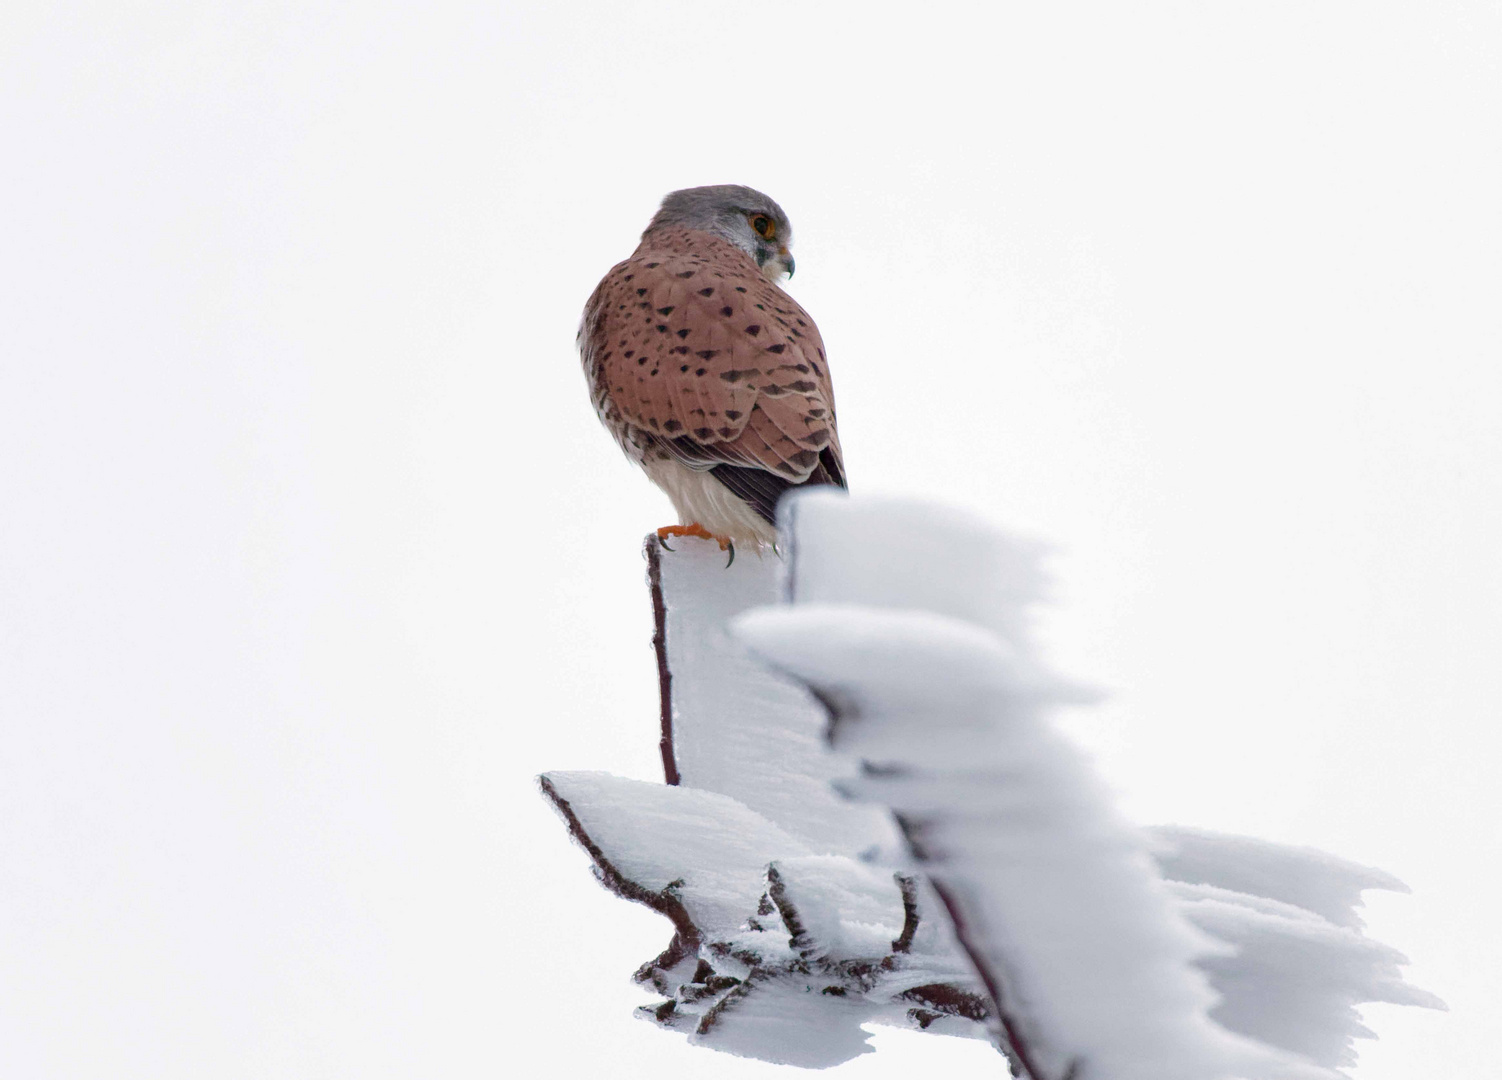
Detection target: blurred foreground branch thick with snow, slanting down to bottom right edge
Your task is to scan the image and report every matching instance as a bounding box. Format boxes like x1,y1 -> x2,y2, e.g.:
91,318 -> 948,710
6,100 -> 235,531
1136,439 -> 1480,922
734,606 -> 1320,1080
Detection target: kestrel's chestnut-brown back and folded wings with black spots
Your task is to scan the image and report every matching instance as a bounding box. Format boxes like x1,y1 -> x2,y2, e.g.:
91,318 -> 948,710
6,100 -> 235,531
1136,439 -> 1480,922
580,231 -> 844,518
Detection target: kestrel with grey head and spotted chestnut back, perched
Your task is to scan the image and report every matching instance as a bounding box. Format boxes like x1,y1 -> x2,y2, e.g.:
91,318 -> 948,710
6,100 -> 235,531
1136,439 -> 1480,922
578,183 -> 846,557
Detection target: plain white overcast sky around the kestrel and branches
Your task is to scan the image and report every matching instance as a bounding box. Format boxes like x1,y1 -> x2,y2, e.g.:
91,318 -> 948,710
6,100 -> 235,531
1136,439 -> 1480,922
0,0 -> 1502,1080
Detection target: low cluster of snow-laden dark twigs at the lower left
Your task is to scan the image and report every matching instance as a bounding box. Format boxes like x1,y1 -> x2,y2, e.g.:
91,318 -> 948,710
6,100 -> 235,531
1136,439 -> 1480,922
542,772 -> 985,1068
